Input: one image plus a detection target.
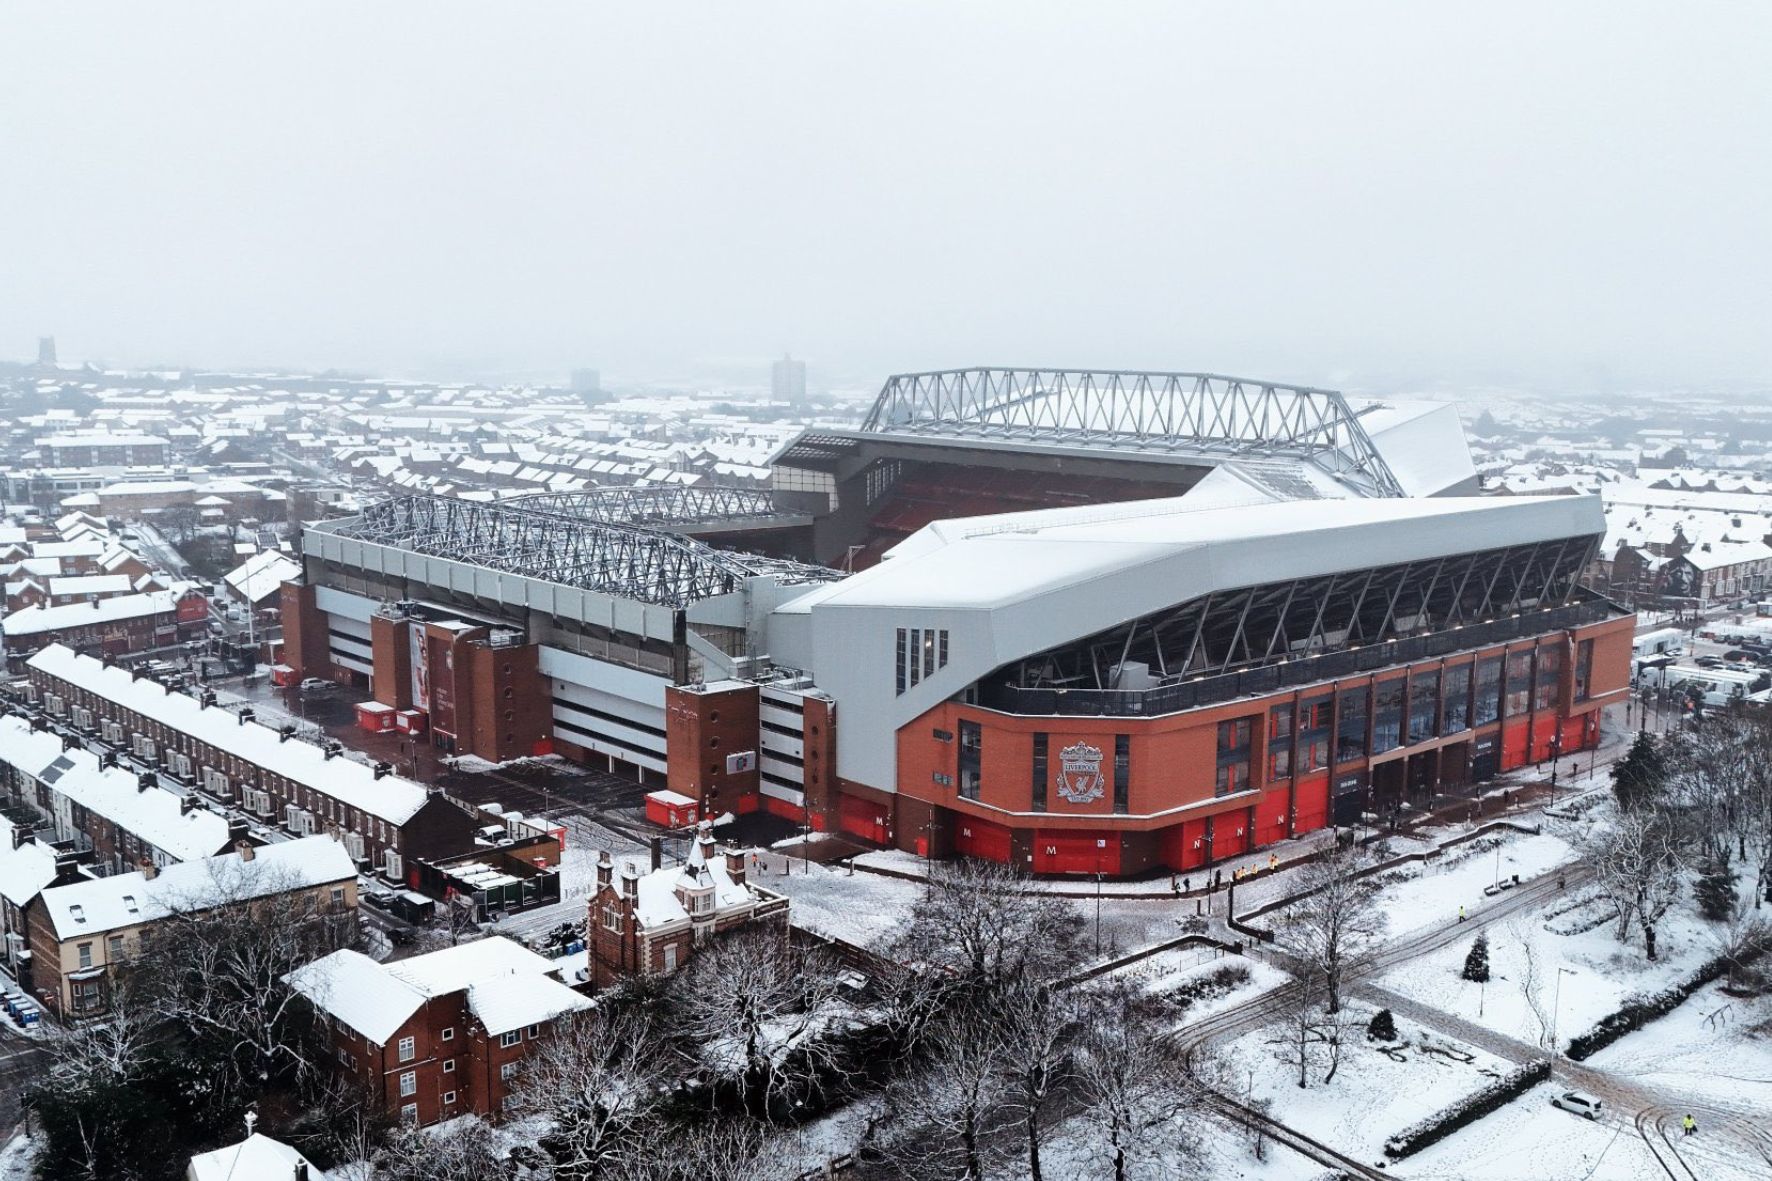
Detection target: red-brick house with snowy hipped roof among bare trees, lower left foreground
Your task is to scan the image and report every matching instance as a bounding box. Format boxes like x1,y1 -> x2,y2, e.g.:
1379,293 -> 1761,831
285,936 -> 592,1124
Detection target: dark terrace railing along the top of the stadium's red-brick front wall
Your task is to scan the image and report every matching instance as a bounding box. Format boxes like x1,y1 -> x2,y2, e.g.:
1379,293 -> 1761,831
978,599 -> 1618,718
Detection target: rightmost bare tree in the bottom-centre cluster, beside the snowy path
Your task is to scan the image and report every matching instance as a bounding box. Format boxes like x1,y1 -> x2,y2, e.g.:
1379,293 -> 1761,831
1076,984 -> 1216,1181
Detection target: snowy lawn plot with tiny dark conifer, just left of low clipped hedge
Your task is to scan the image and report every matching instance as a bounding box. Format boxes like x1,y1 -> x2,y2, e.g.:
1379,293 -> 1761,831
1224,1002 -> 1529,1176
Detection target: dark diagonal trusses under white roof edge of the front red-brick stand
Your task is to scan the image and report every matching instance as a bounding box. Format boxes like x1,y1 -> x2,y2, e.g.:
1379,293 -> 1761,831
1008,537 -> 1598,690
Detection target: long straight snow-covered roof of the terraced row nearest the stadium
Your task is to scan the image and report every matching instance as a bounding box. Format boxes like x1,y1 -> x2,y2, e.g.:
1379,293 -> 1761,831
26,645 -> 427,825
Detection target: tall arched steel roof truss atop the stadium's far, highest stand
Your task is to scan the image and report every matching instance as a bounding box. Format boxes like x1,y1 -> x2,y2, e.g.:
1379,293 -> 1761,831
861,369 -> 1403,497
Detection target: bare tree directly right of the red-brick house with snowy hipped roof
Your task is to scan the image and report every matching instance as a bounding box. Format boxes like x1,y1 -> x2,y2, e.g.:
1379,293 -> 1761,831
512,998 -> 670,1177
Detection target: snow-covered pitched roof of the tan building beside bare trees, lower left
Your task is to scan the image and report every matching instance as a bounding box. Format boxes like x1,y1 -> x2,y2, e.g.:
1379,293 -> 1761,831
43,837 -> 356,940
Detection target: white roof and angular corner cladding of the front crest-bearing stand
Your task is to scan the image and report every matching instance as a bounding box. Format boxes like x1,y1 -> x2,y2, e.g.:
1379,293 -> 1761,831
767,495 -> 1605,787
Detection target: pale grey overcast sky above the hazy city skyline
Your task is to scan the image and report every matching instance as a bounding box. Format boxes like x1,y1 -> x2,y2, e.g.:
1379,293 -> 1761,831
0,0 -> 1772,387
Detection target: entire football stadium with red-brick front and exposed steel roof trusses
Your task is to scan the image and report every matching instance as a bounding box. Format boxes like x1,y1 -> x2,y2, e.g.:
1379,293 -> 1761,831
282,369 -> 1632,874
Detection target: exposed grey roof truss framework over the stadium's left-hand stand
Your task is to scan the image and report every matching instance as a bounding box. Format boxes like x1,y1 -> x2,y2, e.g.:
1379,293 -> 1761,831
347,495 -> 840,606
